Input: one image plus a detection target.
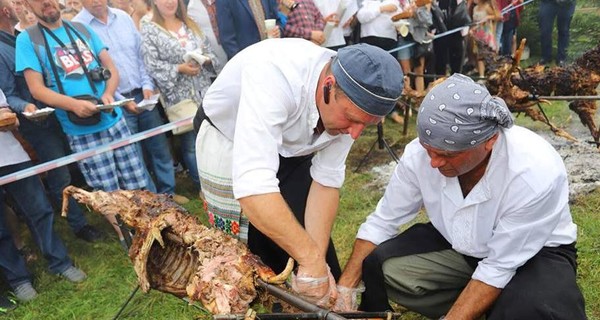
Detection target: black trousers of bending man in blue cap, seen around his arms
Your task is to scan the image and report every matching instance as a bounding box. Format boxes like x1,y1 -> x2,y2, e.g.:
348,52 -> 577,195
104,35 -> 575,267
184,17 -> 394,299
248,155 -> 342,280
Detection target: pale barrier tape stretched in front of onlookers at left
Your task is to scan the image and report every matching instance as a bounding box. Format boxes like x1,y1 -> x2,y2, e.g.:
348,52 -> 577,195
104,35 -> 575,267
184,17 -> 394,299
0,117 -> 194,186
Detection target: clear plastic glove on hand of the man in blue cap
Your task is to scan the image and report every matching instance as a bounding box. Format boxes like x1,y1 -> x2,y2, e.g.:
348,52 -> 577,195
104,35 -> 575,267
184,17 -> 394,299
290,267 -> 338,308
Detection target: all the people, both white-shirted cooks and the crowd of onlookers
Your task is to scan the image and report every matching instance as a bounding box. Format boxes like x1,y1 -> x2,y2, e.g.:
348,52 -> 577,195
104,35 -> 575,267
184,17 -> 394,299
0,0 -> 585,319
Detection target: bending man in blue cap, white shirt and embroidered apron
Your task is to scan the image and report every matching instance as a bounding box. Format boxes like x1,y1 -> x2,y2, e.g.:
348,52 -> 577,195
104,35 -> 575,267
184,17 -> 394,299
196,39 -> 403,305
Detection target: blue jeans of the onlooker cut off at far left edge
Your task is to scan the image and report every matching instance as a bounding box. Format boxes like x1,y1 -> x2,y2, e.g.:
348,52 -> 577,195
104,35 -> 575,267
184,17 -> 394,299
0,161 -> 73,289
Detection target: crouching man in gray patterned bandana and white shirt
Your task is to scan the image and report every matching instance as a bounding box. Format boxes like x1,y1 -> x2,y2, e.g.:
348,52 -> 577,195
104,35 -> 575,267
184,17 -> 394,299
337,74 -> 586,320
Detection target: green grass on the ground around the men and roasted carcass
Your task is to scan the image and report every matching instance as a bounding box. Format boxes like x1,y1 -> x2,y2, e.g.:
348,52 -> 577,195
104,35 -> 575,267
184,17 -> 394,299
5,98 -> 600,320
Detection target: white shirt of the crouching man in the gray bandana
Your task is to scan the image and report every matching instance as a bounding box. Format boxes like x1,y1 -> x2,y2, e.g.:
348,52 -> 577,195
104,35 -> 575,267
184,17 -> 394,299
357,126 -> 577,288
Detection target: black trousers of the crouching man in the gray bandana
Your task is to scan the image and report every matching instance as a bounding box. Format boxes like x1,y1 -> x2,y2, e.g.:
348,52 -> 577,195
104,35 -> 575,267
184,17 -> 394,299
359,223 -> 587,320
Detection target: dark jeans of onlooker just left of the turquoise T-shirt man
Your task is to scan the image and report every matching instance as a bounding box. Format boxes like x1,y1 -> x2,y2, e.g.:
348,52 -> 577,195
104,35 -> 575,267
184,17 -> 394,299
19,115 -> 87,232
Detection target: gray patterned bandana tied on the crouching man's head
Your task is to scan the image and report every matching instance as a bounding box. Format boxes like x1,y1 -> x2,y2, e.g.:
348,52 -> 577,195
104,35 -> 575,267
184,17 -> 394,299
417,73 -> 513,151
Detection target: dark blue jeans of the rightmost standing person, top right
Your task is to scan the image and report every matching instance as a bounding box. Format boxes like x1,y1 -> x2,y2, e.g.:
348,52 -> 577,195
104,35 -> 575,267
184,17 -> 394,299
538,0 -> 576,62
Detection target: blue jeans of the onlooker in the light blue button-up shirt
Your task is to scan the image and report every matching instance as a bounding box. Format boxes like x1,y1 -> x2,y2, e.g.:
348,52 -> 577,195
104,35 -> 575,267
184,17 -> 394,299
123,93 -> 175,194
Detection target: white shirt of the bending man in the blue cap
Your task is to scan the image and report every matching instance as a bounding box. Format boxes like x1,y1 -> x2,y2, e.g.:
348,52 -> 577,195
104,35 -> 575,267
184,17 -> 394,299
203,38 -> 354,199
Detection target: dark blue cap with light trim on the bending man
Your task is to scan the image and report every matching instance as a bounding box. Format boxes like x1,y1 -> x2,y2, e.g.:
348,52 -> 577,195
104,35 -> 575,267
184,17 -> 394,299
331,43 -> 404,117
